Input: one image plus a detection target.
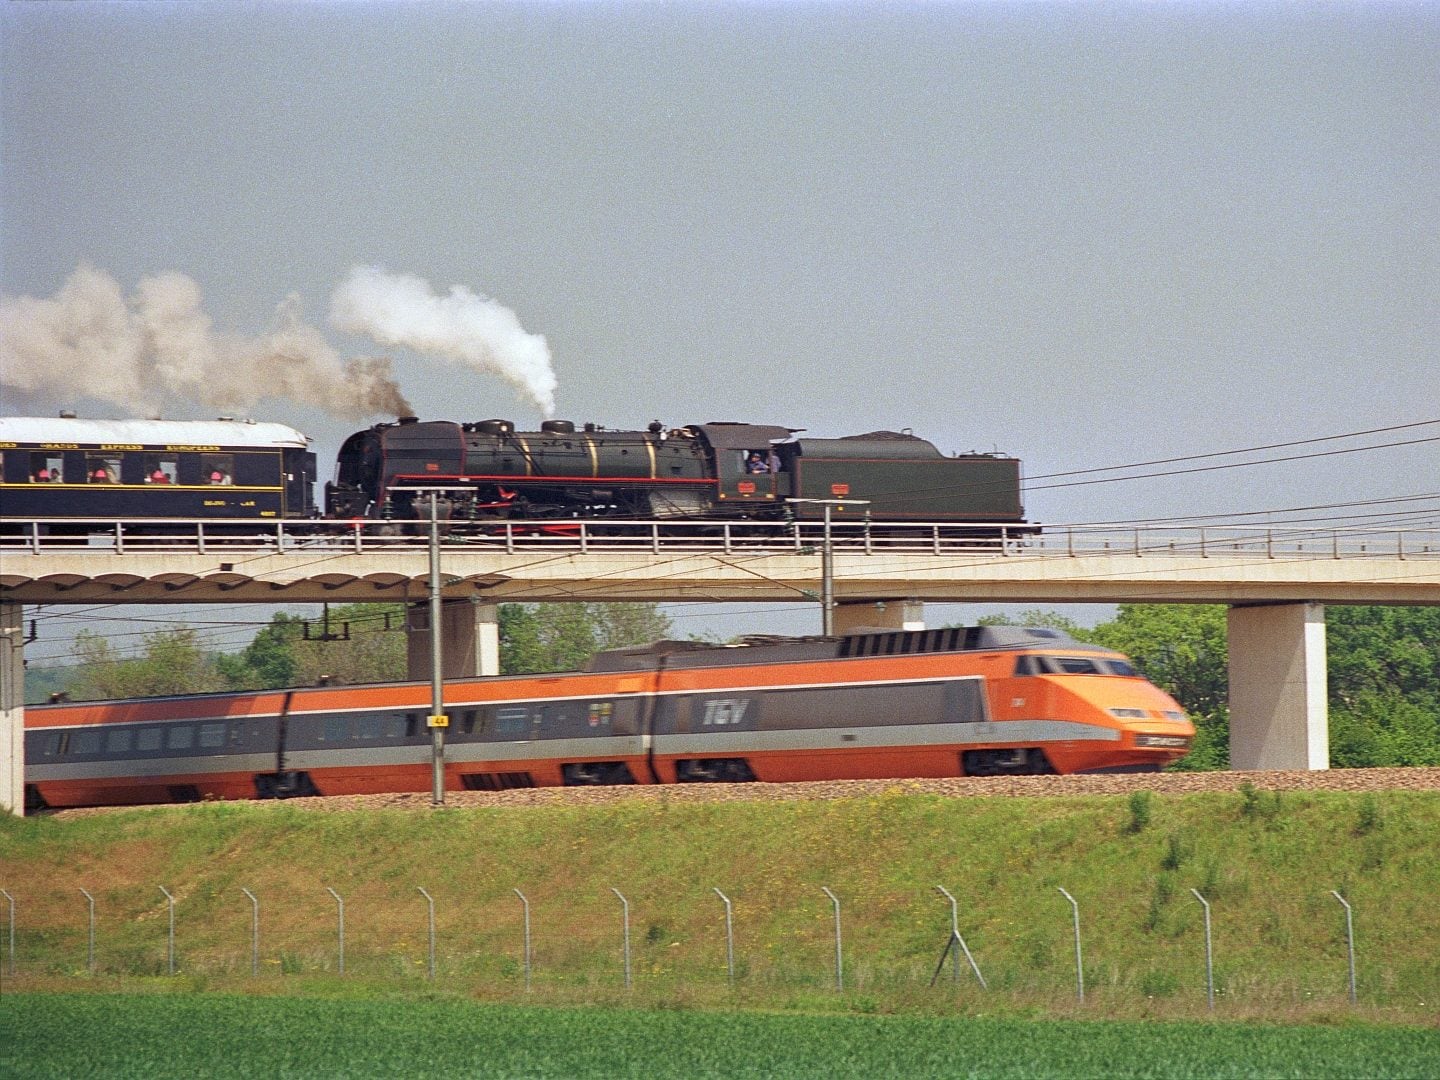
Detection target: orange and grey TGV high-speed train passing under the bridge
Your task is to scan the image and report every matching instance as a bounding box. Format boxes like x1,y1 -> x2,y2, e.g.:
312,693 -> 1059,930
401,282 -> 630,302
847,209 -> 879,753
26,626 -> 1195,809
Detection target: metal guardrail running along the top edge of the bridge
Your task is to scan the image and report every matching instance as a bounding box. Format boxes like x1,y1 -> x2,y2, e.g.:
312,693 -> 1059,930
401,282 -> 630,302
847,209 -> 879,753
0,518 -> 1440,559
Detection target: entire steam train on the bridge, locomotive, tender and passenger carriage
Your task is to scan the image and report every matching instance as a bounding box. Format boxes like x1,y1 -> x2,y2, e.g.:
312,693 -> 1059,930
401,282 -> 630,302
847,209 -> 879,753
0,415 -> 1025,534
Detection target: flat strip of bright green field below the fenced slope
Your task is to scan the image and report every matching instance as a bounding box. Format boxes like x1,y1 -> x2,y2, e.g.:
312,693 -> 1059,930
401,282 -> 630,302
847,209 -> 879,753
0,994 -> 1440,1080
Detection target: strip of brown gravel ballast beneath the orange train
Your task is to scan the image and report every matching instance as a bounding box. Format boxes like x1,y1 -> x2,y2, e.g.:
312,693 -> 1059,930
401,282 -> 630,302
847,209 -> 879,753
42,768 -> 1440,816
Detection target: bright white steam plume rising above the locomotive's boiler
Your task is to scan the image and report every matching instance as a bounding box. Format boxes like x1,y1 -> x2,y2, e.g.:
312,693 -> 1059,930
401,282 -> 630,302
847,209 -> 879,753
330,266 -> 556,416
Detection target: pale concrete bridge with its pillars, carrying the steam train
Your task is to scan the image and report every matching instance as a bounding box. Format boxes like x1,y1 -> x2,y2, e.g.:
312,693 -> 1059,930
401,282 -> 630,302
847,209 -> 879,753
0,523 -> 1440,809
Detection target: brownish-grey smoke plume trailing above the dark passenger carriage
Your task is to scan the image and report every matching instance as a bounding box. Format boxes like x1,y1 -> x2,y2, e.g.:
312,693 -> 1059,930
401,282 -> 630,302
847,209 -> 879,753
0,265 -> 410,419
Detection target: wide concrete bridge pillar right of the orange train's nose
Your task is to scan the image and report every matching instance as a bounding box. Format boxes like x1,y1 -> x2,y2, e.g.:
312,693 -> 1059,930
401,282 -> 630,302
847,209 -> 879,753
1228,603 -> 1331,769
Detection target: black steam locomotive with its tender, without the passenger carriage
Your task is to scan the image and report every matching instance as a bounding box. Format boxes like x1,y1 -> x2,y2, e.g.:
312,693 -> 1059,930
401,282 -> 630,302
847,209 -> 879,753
325,418 -> 1024,524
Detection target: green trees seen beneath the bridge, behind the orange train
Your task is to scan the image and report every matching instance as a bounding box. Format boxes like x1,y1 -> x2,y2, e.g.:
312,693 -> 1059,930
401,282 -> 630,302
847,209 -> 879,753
26,603 -> 1440,769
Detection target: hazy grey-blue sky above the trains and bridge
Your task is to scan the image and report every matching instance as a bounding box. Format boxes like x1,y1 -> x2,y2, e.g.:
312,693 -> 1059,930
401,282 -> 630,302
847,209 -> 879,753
0,0 -> 1440,659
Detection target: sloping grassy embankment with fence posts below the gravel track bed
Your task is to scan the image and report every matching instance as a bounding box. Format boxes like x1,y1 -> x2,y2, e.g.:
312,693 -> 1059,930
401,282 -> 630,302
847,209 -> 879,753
0,785 -> 1440,1022
